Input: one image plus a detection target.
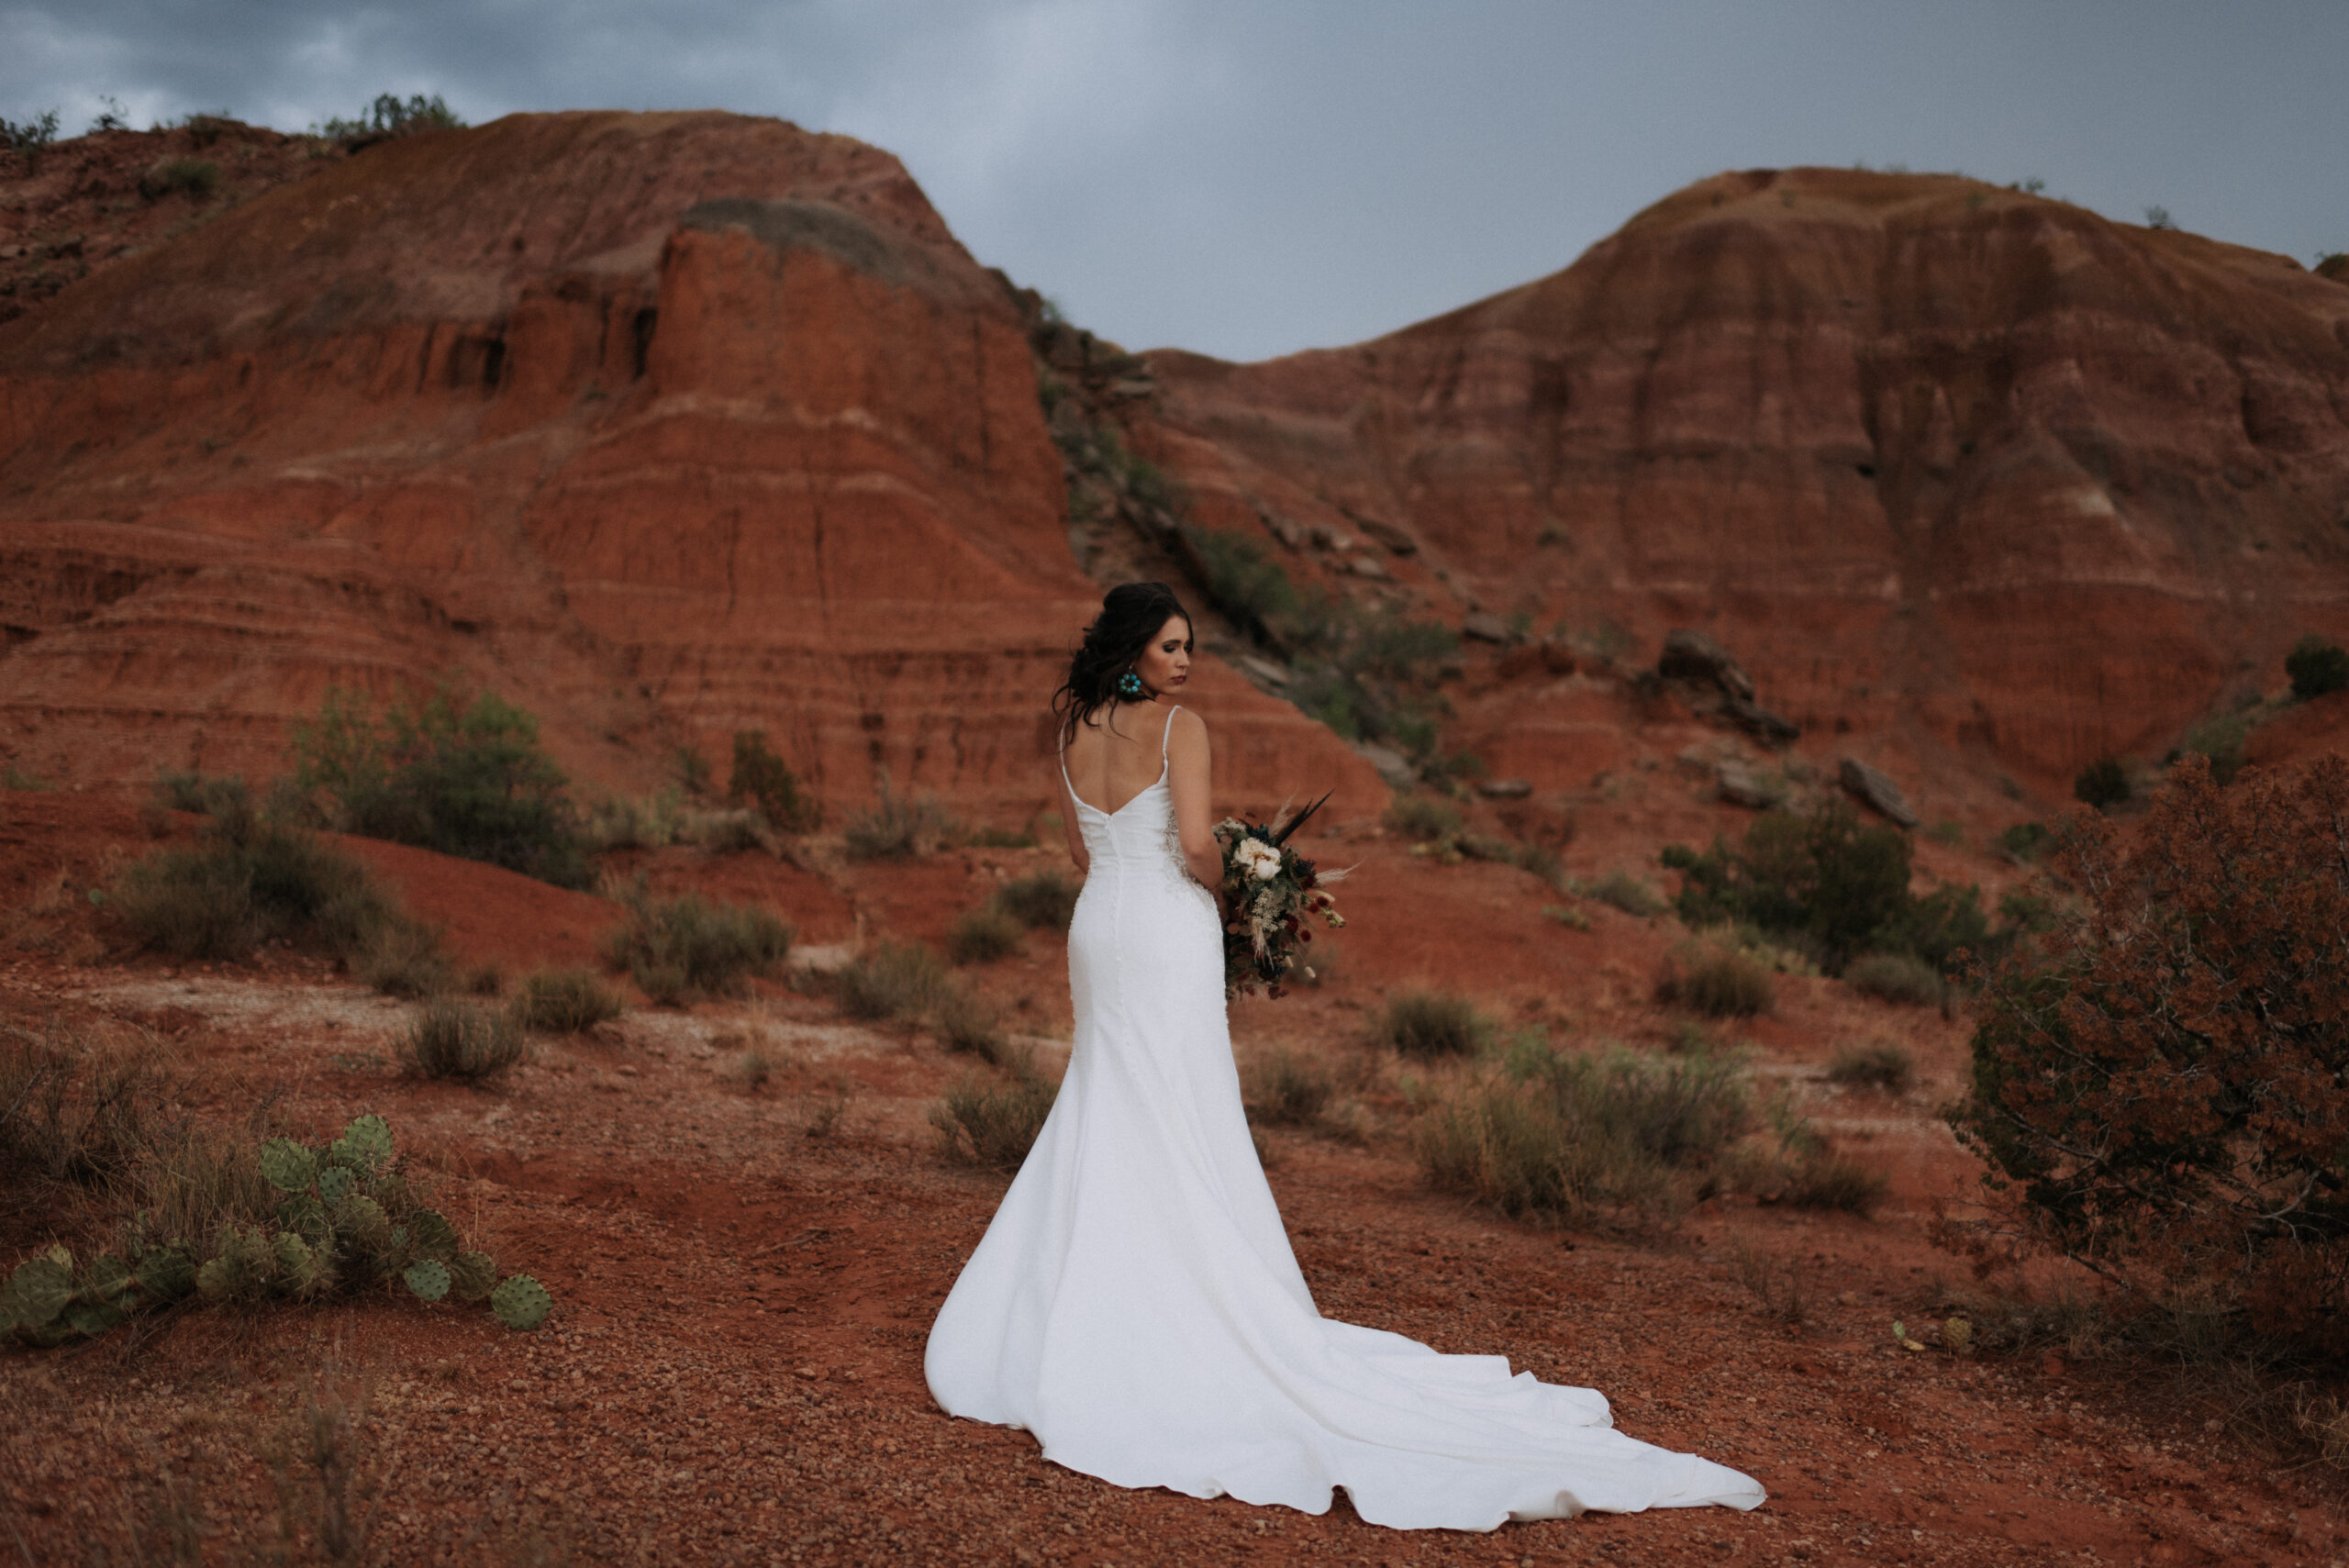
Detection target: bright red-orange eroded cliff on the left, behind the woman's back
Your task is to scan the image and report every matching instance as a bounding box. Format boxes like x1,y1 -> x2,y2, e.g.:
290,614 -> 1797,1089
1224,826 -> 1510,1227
0,113 -> 1384,810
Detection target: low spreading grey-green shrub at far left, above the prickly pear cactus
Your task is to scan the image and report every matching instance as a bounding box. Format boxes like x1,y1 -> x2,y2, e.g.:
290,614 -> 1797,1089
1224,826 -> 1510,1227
108,798 -> 446,991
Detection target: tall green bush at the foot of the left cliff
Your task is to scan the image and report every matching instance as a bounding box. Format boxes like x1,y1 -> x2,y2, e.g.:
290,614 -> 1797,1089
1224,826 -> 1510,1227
294,685 -> 595,887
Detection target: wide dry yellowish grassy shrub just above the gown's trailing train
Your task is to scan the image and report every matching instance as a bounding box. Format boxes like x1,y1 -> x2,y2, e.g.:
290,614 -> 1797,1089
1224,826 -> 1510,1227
1414,1044 -> 1753,1223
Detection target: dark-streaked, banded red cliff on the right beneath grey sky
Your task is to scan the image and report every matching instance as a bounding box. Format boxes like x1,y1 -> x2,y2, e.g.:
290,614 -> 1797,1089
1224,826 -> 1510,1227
1141,169 -> 2349,795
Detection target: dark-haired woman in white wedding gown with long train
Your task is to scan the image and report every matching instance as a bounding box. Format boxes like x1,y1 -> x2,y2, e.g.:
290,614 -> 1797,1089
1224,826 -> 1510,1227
928,582 -> 1762,1530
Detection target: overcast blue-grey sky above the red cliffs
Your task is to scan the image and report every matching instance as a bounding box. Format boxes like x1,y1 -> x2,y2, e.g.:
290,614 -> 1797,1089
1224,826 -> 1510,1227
14,0 -> 2349,359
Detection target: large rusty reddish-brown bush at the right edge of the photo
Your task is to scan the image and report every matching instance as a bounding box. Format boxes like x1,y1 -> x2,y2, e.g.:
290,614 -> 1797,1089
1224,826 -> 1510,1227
1943,756 -> 2349,1359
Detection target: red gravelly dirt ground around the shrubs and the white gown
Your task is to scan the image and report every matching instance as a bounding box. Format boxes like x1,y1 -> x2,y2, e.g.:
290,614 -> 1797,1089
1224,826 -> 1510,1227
0,784 -> 2349,1568
